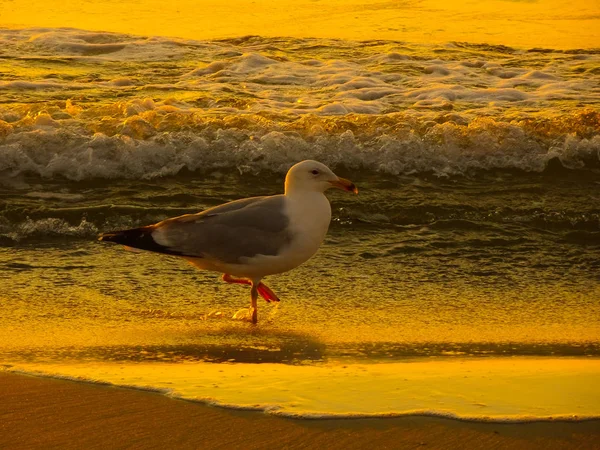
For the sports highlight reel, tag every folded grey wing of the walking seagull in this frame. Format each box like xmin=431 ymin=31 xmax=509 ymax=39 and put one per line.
xmin=152 ymin=195 xmax=291 ymax=264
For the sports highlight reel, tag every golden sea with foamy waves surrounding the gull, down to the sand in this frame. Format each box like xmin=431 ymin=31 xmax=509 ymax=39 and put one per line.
xmin=0 ymin=28 xmax=600 ymax=421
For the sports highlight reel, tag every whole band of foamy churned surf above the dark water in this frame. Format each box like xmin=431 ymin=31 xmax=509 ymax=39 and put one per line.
xmin=0 ymin=29 xmax=600 ymax=180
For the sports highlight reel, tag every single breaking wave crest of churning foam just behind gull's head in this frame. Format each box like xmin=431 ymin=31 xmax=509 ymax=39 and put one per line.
xmin=0 ymin=110 xmax=600 ymax=180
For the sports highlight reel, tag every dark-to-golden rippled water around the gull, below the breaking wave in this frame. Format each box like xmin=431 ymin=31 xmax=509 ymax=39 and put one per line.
xmin=0 ymin=170 xmax=600 ymax=362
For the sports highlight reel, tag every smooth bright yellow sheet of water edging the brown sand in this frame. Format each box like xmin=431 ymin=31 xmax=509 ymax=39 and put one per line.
xmin=5 ymin=358 xmax=600 ymax=423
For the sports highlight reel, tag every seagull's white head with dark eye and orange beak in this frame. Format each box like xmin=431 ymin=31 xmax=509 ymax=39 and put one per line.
xmin=285 ymin=160 xmax=358 ymax=194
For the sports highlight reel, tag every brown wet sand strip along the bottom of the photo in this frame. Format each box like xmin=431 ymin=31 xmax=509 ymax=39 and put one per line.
xmin=0 ymin=373 xmax=600 ymax=449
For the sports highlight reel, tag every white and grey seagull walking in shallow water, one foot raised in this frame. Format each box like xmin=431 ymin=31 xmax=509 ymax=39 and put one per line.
xmin=98 ymin=160 xmax=358 ymax=324
